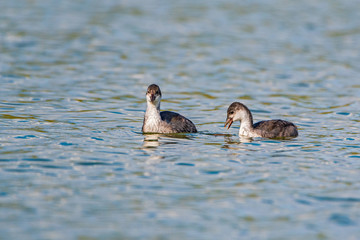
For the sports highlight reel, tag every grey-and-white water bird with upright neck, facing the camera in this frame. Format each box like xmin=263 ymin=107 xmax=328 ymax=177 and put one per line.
xmin=142 ymin=84 xmax=197 ymax=133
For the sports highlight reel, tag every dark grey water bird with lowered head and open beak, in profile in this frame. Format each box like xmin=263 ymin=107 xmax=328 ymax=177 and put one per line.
xmin=224 ymin=102 xmax=298 ymax=138
